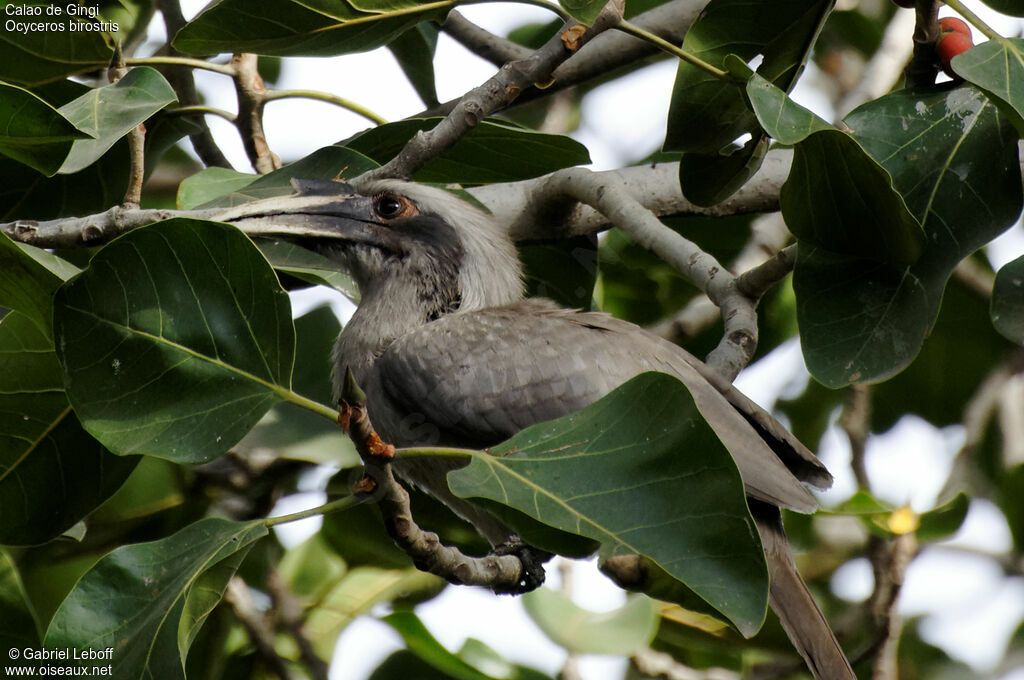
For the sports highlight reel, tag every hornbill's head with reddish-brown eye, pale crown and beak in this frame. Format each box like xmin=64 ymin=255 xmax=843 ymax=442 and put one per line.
xmin=260 ymin=179 xmax=522 ymax=317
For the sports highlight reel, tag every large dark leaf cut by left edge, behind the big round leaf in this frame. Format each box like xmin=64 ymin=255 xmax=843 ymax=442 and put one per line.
xmin=0 ymin=235 xmax=136 ymax=545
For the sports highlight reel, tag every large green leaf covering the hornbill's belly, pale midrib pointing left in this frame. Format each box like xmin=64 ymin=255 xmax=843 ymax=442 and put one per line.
xmin=449 ymin=374 xmax=768 ymax=634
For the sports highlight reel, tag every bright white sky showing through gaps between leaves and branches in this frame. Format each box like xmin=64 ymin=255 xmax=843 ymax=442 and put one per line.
xmin=153 ymin=0 xmax=1024 ymax=680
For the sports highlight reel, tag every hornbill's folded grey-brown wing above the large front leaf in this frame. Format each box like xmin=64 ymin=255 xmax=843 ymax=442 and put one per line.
xmin=367 ymin=300 xmax=827 ymax=512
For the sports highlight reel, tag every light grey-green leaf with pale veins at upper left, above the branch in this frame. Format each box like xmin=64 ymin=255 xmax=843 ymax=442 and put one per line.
xmin=60 ymin=67 xmax=177 ymax=174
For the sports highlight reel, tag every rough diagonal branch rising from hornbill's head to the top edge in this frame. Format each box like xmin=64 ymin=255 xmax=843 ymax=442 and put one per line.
xmin=364 ymin=0 xmax=623 ymax=182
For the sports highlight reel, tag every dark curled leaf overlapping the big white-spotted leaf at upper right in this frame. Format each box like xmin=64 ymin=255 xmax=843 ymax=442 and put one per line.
xmin=779 ymin=130 xmax=925 ymax=267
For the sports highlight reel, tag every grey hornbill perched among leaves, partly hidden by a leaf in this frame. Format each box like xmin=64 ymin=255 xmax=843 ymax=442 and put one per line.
xmin=270 ymin=180 xmax=855 ymax=680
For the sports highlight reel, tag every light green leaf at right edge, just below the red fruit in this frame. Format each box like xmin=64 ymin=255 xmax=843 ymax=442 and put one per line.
xmin=951 ymin=38 xmax=1024 ymax=135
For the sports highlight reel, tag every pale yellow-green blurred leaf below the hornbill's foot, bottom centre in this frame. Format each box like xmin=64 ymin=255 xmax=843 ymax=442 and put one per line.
xmin=522 ymin=588 xmax=658 ymax=656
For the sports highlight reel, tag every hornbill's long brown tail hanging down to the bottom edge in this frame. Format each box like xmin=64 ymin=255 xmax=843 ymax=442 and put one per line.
xmin=755 ymin=506 xmax=857 ymax=680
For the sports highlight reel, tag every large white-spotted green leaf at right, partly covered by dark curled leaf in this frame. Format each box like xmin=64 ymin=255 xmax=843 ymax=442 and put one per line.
xmin=794 ymin=85 xmax=1022 ymax=387
